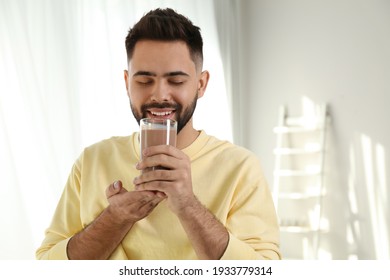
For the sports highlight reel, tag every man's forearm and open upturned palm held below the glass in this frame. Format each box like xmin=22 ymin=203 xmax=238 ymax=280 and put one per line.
xmin=67 ymin=181 xmax=165 ymax=260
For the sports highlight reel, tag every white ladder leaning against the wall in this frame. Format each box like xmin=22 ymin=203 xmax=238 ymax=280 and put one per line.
xmin=273 ymin=104 xmax=328 ymax=259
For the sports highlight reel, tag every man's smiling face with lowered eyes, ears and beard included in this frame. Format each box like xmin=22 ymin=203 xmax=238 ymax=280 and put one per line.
xmin=125 ymin=40 xmax=208 ymax=135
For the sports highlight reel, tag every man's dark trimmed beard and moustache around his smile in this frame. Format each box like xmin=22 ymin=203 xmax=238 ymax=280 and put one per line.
xmin=130 ymin=93 xmax=198 ymax=134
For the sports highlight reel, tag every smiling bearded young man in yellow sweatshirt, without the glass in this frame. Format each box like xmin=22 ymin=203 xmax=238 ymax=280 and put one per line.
xmin=36 ymin=9 xmax=280 ymax=259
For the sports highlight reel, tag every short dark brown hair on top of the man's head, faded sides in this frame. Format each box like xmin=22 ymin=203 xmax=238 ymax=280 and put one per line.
xmin=125 ymin=8 xmax=203 ymax=69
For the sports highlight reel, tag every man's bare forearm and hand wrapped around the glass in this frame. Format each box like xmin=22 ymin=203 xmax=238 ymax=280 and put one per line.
xmin=134 ymin=145 xmax=229 ymax=259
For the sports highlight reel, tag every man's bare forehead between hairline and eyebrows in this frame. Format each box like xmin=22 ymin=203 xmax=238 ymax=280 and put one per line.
xmin=129 ymin=40 xmax=195 ymax=72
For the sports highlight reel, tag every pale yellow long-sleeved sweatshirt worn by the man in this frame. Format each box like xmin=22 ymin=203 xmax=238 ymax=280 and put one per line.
xmin=36 ymin=131 xmax=280 ymax=260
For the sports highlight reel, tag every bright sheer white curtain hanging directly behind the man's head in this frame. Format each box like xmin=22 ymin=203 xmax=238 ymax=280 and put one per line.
xmin=0 ymin=0 xmax=232 ymax=259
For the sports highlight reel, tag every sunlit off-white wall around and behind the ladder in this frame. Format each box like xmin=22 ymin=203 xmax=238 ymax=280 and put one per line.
xmin=239 ymin=0 xmax=390 ymax=259
